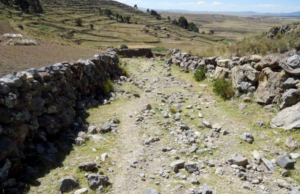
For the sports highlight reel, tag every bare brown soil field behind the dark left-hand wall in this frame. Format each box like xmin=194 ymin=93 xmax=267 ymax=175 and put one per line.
xmin=0 ymin=21 xmax=100 ymax=76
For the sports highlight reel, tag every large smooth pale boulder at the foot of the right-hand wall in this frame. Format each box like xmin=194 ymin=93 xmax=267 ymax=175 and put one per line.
xmin=270 ymin=103 xmax=300 ymax=130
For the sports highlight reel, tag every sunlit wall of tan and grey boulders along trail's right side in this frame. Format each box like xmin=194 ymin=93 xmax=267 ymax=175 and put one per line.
xmin=165 ymin=49 xmax=300 ymax=130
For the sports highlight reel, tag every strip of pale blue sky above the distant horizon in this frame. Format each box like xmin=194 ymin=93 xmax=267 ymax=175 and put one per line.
xmin=117 ymin=0 xmax=300 ymax=13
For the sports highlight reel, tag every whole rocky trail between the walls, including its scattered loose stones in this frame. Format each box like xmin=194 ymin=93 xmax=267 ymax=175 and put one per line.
xmin=29 ymin=56 xmax=300 ymax=194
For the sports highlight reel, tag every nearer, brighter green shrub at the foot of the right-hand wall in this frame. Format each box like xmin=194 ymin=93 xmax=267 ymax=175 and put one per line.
xmin=213 ymin=79 xmax=234 ymax=100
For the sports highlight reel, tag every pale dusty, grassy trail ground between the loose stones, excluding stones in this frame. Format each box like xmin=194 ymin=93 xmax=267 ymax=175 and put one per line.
xmin=30 ymin=59 xmax=300 ymax=194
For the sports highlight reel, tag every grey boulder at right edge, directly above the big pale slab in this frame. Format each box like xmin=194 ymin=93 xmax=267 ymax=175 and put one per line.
xmin=280 ymin=89 xmax=300 ymax=109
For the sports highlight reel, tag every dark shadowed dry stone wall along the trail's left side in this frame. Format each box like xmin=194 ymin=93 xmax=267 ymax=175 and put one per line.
xmin=0 ymin=51 xmax=122 ymax=189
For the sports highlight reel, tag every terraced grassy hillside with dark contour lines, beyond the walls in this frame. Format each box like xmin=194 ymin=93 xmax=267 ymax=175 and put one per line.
xmin=2 ymin=0 xmax=222 ymax=52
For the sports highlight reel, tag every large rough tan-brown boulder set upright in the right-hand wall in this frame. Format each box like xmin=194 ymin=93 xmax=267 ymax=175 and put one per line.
xmin=254 ymin=68 xmax=287 ymax=104
